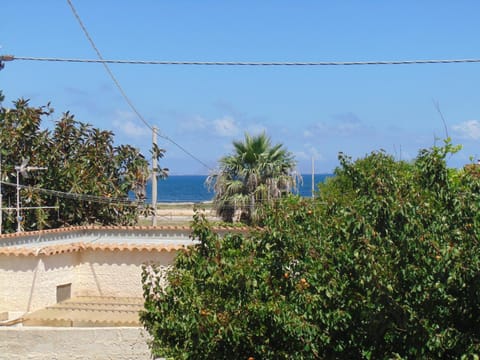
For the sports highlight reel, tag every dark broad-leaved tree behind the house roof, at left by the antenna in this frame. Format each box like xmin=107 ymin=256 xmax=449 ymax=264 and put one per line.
xmin=0 ymin=93 xmax=164 ymax=232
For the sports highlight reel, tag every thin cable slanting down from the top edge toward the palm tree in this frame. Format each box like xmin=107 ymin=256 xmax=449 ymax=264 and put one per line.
xmin=63 ymin=0 xmax=212 ymax=170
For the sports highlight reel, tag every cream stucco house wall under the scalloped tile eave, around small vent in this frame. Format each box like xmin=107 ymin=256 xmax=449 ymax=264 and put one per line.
xmin=0 ymin=250 xmax=176 ymax=312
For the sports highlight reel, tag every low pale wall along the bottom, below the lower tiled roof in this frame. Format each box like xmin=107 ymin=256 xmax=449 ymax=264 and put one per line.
xmin=0 ymin=327 xmax=158 ymax=360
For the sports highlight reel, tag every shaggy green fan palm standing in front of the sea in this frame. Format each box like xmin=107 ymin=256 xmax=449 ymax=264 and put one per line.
xmin=206 ymin=133 xmax=300 ymax=223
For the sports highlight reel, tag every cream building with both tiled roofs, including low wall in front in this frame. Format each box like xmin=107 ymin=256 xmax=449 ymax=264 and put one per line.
xmin=0 ymin=226 xmax=194 ymax=359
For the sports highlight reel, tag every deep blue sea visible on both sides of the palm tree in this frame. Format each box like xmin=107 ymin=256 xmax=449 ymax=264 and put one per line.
xmin=147 ymin=174 xmax=332 ymax=203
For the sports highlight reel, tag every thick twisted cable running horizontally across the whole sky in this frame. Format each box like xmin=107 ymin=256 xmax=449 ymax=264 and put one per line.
xmin=0 ymin=54 xmax=480 ymax=66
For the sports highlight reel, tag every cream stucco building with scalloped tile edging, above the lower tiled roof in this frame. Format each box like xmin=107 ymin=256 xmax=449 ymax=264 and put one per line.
xmin=0 ymin=226 xmax=193 ymax=320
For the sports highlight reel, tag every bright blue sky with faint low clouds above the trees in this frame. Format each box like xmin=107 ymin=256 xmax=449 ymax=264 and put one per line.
xmin=0 ymin=0 xmax=480 ymax=175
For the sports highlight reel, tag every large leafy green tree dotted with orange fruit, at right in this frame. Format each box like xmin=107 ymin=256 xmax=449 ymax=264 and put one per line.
xmin=141 ymin=141 xmax=480 ymax=359
